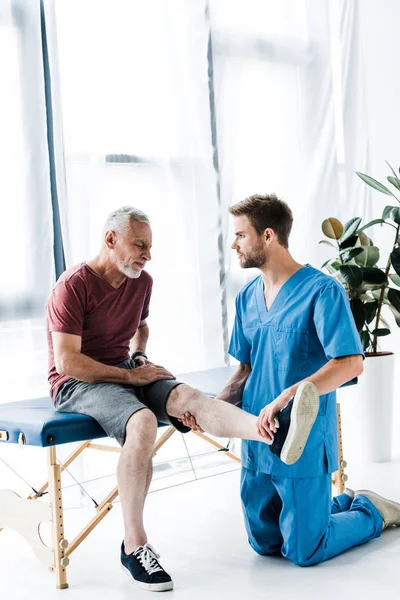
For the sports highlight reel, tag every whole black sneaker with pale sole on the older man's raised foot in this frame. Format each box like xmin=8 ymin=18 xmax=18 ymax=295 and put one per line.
xmin=270 ymin=381 xmax=319 ymax=465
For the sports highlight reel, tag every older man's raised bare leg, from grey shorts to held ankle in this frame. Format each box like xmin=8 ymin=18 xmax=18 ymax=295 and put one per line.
xmin=166 ymin=384 xmax=271 ymax=444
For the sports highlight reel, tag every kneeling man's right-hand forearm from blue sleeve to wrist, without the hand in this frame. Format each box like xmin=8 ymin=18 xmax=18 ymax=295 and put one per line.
xmin=289 ymin=355 xmax=363 ymax=396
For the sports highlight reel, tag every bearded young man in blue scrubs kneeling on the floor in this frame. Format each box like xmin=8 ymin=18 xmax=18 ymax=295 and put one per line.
xmin=184 ymin=194 xmax=400 ymax=566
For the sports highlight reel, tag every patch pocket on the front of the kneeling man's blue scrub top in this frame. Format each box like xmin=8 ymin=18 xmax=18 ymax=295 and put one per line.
xmin=271 ymin=327 xmax=308 ymax=372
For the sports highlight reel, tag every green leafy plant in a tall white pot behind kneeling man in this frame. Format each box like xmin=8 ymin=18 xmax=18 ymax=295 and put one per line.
xmin=320 ymin=164 xmax=400 ymax=461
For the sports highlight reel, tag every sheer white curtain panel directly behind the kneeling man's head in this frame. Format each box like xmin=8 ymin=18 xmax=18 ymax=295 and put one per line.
xmin=210 ymin=0 xmax=341 ymax=330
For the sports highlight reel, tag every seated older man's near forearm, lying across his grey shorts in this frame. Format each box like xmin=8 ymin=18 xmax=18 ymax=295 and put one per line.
xmin=56 ymin=352 xmax=129 ymax=384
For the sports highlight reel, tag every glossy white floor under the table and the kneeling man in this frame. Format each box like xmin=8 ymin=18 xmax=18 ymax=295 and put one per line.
xmin=0 ymin=454 xmax=400 ymax=600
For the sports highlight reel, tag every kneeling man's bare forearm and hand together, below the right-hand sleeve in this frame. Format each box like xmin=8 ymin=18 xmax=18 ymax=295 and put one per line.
xmin=257 ymin=354 xmax=363 ymax=437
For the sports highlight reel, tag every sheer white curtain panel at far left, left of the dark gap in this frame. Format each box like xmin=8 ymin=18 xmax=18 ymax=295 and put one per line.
xmin=0 ymin=0 xmax=54 ymax=403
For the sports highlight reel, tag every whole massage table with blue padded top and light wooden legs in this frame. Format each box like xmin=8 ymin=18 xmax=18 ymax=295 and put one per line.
xmin=0 ymin=366 xmax=347 ymax=589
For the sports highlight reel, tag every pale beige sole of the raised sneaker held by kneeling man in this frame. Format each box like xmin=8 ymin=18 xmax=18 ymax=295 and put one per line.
xmin=280 ymin=381 xmax=319 ymax=465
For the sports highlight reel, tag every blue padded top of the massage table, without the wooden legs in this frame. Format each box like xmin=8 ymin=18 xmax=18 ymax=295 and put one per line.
xmin=0 ymin=367 xmax=236 ymax=447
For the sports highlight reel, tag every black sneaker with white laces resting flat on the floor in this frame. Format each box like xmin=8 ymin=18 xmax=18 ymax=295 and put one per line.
xmin=121 ymin=542 xmax=174 ymax=592
